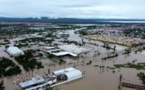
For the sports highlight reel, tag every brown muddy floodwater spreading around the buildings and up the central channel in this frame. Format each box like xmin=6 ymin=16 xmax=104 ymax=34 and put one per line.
xmin=0 ymin=30 xmax=145 ymax=90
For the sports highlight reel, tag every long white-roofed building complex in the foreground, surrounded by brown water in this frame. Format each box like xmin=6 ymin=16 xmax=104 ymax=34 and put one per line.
xmin=19 ymin=67 xmax=84 ymax=90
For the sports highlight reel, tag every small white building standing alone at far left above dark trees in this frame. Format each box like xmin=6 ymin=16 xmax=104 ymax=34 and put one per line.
xmin=7 ymin=47 xmax=24 ymax=56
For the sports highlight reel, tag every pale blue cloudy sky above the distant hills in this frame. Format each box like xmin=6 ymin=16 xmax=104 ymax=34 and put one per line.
xmin=0 ymin=0 xmax=145 ymax=19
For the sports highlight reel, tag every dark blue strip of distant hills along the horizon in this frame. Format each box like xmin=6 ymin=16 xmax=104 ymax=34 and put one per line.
xmin=0 ymin=17 xmax=145 ymax=23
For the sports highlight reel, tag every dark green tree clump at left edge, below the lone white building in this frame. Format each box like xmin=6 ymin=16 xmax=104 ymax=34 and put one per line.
xmin=0 ymin=57 xmax=21 ymax=77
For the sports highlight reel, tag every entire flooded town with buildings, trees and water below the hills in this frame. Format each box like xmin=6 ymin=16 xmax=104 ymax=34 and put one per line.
xmin=0 ymin=21 xmax=145 ymax=90
